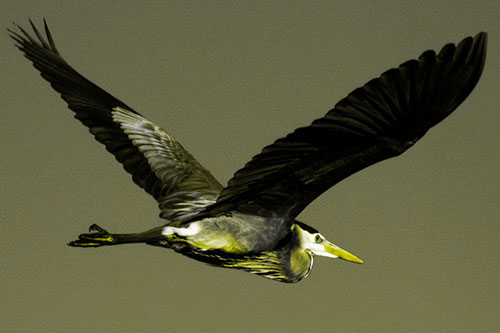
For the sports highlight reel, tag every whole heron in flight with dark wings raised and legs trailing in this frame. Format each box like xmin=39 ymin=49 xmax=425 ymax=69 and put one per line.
xmin=8 ymin=20 xmax=487 ymax=282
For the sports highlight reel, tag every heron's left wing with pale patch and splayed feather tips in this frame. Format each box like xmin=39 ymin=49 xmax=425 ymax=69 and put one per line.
xmin=9 ymin=20 xmax=222 ymax=223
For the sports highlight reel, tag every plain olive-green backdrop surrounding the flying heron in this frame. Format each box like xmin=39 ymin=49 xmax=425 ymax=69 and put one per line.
xmin=0 ymin=0 xmax=500 ymax=332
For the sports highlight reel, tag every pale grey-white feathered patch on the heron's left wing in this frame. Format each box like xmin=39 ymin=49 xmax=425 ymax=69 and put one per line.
xmin=111 ymin=107 xmax=222 ymax=221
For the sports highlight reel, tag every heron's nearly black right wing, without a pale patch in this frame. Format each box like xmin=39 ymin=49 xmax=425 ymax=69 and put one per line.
xmin=204 ymin=32 xmax=487 ymax=220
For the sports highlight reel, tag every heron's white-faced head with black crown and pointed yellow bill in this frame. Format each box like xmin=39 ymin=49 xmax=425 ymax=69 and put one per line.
xmin=292 ymin=221 xmax=363 ymax=264
